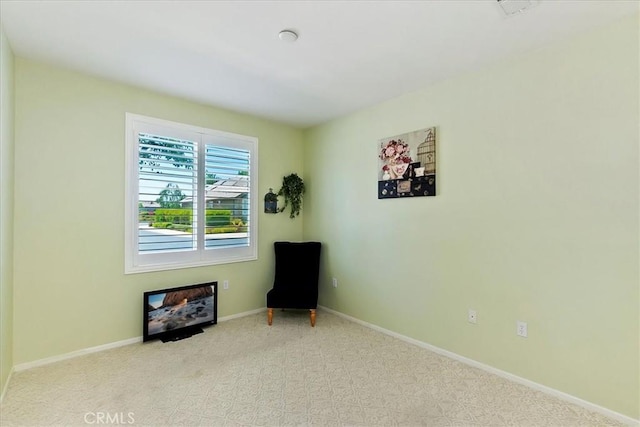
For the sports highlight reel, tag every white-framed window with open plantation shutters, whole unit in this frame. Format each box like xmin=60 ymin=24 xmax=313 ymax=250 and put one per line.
xmin=125 ymin=113 xmax=258 ymax=273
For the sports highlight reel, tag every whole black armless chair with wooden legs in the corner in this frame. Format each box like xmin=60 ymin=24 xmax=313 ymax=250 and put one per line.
xmin=267 ymin=242 xmax=321 ymax=326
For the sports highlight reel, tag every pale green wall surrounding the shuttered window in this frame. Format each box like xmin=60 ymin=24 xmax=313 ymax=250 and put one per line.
xmin=13 ymin=57 xmax=303 ymax=365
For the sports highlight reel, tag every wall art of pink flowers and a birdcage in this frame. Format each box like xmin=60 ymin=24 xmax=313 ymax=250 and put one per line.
xmin=378 ymin=127 xmax=436 ymax=199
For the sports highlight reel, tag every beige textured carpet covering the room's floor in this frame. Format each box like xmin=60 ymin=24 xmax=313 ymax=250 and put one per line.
xmin=0 ymin=311 xmax=621 ymax=427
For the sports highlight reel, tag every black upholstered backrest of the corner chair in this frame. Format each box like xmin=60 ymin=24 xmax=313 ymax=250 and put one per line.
xmin=273 ymin=242 xmax=321 ymax=293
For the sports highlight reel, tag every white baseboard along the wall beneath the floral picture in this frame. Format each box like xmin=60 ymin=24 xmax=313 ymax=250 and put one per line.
xmin=318 ymin=306 xmax=640 ymax=427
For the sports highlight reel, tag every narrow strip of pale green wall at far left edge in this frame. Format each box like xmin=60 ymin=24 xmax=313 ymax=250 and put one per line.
xmin=0 ymin=27 xmax=14 ymax=393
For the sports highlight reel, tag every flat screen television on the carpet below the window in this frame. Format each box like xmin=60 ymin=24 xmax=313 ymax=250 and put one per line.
xmin=142 ymin=282 xmax=218 ymax=342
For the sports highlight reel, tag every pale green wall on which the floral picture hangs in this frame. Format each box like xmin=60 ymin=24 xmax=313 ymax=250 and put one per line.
xmin=304 ymin=12 xmax=640 ymax=419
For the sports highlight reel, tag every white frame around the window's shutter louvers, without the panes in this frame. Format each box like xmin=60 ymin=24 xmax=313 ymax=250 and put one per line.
xmin=124 ymin=113 xmax=258 ymax=274
